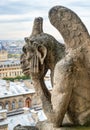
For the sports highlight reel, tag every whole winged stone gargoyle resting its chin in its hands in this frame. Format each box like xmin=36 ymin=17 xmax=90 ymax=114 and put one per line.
xmin=21 ymin=6 xmax=90 ymax=127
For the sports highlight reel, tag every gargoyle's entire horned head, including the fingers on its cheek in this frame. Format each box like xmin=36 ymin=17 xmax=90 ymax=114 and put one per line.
xmin=21 ymin=17 xmax=65 ymax=75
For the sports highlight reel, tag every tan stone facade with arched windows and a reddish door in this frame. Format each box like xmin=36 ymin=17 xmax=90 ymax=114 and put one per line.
xmin=0 ymin=94 xmax=33 ymax=111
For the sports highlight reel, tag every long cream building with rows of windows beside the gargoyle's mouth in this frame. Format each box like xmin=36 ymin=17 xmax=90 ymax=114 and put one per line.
xmin=0 ymin=60 xmax=23 ymax=79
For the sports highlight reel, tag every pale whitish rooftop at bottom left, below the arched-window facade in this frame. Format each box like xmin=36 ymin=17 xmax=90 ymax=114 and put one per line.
xmin=0 ymin=110 xmax=47 ymax=130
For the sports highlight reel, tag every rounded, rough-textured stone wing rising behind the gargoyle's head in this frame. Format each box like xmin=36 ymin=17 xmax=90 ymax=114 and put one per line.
xmin=49 ymin=6 xmax=90 ymax=49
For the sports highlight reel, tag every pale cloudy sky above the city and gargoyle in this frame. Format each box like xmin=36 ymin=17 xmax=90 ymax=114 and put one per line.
xmin=0 ymin=0 xmax=90 ymax=40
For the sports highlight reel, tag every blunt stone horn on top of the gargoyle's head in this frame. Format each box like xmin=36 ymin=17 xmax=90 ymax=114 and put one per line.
xmin=30 ymin=17 xmax=43 ymax=37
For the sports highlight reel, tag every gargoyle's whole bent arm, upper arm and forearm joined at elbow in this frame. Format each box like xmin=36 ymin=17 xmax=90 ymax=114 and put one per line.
xmin=34 ymin=58 xmax=73 ymax=127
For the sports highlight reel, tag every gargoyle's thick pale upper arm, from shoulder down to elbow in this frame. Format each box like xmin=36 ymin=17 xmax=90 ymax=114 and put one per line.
xmin=49 ymin=59 xmax=74 ymax=127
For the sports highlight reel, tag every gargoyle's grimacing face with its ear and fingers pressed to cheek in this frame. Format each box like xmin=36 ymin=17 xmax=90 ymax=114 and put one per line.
xmin=21 ymin=38 xmax=47 ymax=75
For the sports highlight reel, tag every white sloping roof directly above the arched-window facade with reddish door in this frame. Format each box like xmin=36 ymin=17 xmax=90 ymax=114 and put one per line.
xmin=0 ymin=79 xmax=35 ymax=98
